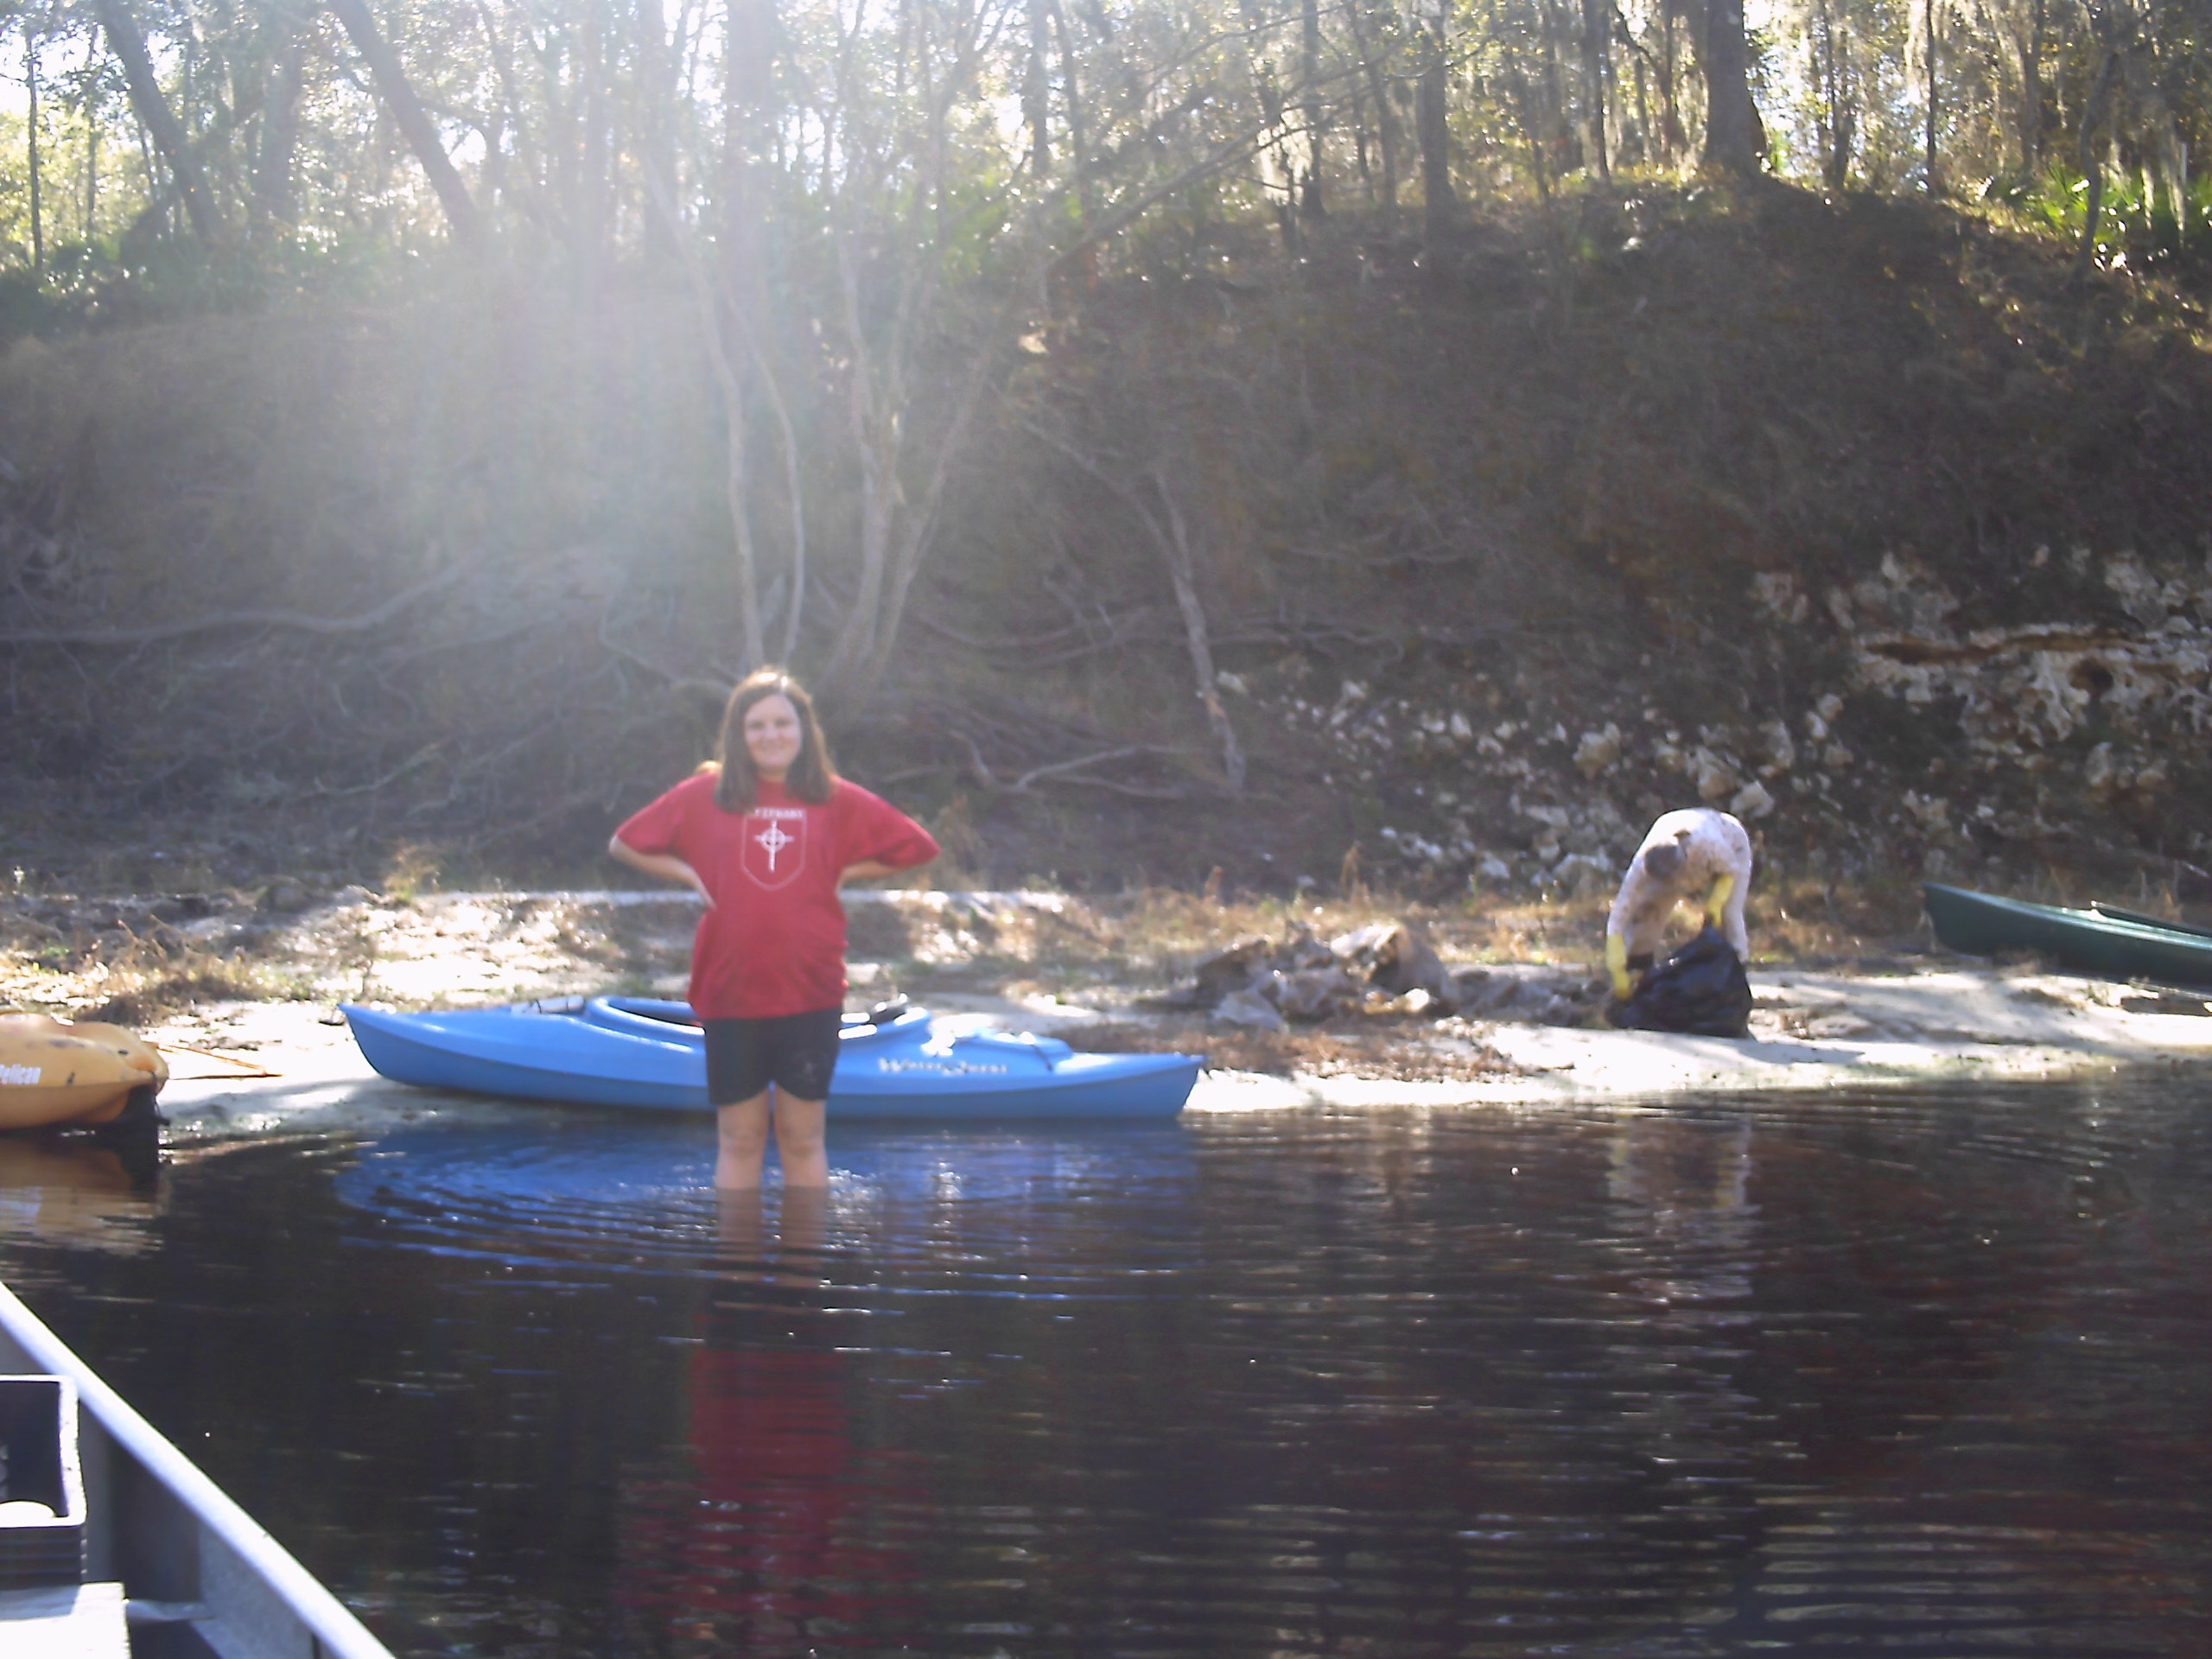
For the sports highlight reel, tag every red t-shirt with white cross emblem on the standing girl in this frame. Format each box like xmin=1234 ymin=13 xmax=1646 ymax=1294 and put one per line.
xmin=615 ymin=772 xmax=938 ymax=1020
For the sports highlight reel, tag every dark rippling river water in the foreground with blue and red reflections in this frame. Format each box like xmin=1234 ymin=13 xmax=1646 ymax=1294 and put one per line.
xmin=0 ymin=1082 xmax=2212 ymax=1659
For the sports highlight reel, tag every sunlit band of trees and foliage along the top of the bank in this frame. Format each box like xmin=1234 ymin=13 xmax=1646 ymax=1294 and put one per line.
xmin=0 ymin=0 xmax=2212 ymax=288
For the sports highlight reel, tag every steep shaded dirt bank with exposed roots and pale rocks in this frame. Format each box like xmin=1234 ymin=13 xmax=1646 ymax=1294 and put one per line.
xmin=0 ymin=186 xmax=2212 ymax=925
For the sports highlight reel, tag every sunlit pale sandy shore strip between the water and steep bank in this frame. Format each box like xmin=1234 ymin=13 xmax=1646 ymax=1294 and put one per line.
xmin=13 ymin=889 xmax=2212 ymax=1141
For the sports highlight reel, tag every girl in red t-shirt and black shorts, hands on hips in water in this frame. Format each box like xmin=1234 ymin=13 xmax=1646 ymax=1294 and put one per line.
xmin=606 ymin=668 xmax=938 ymax=1192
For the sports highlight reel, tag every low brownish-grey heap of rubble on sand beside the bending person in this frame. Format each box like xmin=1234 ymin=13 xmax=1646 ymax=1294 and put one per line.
xmin=1141 ymin=923 xmax=1604 ymax=1031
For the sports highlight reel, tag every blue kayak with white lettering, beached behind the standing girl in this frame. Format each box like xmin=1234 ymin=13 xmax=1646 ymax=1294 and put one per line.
xmin=343 ymin=998 xmax=1204 ymax=1119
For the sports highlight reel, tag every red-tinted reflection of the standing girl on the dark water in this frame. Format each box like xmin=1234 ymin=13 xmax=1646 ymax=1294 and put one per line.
xmin=621 ymin=1188 xmax=913 ymax=1655
